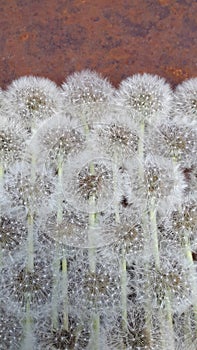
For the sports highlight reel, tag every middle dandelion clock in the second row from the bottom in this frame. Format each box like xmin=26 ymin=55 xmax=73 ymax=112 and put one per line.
xmin=68 ymin=256 xmax=120 ymax=317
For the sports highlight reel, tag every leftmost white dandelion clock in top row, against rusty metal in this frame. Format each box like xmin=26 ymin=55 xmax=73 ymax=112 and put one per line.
xmin=5 ymin=76 xmax=62 ymax=131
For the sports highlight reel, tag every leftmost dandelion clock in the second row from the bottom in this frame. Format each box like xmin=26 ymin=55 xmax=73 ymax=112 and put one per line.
xmin=1 ymin=251 xmax=52 ymax=310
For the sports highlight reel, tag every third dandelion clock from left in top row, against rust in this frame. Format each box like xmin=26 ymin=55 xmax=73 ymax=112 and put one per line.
xmin=116 ymin=73 xmax=172 ymax=124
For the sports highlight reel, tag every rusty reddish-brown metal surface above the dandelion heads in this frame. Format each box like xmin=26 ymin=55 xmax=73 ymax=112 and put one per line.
xmin=0 ymin=0 xmax=197 ymax=88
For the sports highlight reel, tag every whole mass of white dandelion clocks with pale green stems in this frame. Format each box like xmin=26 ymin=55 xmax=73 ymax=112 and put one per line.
xmin=0 ymin=70 xmax=197 ymax=350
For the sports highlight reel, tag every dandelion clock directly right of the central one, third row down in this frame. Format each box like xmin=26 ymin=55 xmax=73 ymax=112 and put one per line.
xmin=124 ymin=155 xmax=186 ymax=213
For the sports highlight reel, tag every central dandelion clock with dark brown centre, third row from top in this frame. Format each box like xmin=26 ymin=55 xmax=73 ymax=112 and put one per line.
xmin=62 ymin=151 xmax=121 ymax=213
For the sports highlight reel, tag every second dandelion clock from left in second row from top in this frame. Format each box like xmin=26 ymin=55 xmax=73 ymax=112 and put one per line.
xmin=26 ymin=114 xmax=85 ymax=176
